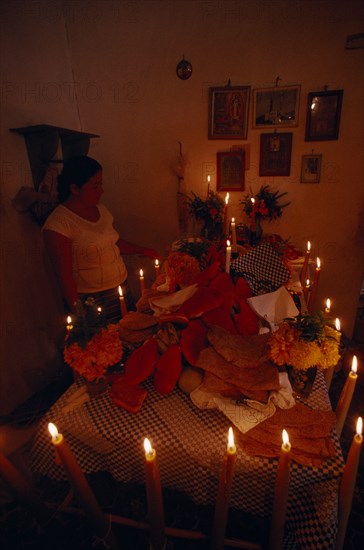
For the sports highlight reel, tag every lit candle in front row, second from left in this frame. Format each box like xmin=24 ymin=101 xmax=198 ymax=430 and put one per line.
xmin=144 ymin=438 xmax=166 ymax=550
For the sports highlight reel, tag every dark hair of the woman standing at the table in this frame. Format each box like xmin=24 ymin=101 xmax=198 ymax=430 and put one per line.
xmin=57 ymin=155 xmax=102 ymax=202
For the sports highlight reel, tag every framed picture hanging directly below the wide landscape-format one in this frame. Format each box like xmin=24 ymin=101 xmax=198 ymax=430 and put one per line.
xmin=259 ymin=132 xmax=292 ymax=176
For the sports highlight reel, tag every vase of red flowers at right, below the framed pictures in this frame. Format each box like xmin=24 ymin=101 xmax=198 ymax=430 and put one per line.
xmin=240 ymin=185 xmax=290 ymax=246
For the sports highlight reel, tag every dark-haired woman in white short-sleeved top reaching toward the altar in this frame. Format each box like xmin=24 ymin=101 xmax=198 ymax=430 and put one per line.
xmin=43 ymin=156 xmax=157 ymax=321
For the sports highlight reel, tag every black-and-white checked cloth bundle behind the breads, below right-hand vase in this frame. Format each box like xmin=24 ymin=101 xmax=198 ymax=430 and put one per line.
xmin=230 ymin=243 xmax=291 ymax=295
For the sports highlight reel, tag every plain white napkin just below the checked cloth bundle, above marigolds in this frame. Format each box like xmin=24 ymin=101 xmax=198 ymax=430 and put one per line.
xmin=247 ymin=286 xmax=299 ymax=332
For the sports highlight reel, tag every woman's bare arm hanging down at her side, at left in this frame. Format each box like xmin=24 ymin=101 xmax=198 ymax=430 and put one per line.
xmin=43 ymin=229 xmax=79 ymax=311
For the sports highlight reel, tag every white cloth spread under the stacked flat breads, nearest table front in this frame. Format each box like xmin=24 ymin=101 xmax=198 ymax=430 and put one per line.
xmin=190 ymin=372 xmax=295 ymax=433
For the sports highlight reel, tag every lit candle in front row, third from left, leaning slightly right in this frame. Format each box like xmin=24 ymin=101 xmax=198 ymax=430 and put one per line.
xmin=210 ymin=427 xmax=236 ymax=550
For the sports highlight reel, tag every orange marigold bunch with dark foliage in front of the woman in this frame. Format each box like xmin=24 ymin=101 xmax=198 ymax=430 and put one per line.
xmin=63 ymin=298 xmax=123 ymax=382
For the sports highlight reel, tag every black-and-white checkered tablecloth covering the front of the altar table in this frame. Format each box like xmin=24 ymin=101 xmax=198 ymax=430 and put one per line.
xmin=32 ymin=373 xmax=343 ymax=549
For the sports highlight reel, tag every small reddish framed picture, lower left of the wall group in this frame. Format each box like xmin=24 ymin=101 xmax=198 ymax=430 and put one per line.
xmin=216 ymin=149 xmax=245 ymax=191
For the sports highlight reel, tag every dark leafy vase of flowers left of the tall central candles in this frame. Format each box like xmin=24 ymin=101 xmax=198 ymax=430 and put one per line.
xmin=185 ymin=190 xmax=225 ymax=241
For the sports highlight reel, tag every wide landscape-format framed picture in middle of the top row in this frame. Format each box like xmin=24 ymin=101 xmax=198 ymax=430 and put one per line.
xmin=253 ymin=85 xmax=301 ymax=128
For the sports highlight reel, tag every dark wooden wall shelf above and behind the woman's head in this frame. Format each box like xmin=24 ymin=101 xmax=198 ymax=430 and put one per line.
xmin=10 ymin=124 xmax=100 ymax=191
